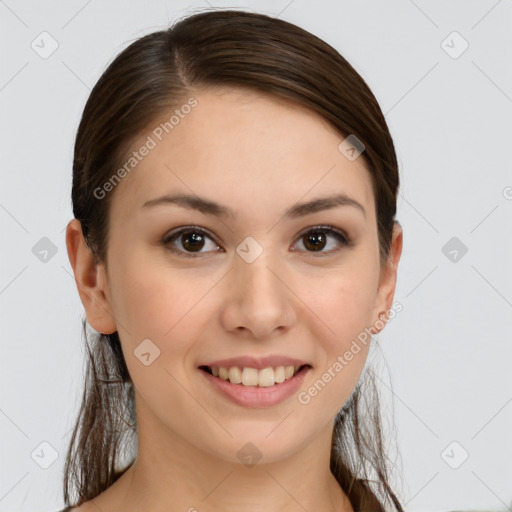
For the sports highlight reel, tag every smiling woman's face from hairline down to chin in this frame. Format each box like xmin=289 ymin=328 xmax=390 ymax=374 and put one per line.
xmin=80 ymin=88 xmax=402 ymax=462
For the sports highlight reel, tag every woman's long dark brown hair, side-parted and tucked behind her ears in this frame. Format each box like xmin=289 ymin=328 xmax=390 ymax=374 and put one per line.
xmin=64 ymin=10 xmax=402 ymax=511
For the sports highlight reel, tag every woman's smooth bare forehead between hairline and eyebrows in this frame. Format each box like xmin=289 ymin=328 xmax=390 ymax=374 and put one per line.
xmin=112 ymin=87 xmax=373 ymax=222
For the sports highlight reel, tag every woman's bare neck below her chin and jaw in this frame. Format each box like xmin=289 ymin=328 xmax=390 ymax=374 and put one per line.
xmin=99 ymin=400 xmax=353 ymax=512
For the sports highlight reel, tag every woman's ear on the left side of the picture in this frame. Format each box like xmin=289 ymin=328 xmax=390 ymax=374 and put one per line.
xmin=66 ymin=219 xmax=117 ymax=334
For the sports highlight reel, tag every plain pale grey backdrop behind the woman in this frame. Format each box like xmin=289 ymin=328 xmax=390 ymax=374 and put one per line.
xmin=0 ymin=0 xmax=512 ymax=512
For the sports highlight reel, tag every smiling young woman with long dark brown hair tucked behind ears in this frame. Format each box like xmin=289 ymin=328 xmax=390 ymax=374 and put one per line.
xmin=64 ymin=10 xmax=402 ymax=512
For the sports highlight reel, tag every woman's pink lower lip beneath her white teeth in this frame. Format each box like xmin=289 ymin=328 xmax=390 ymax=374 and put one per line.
xmin=199 ymin=366 xmax=311 ymax=408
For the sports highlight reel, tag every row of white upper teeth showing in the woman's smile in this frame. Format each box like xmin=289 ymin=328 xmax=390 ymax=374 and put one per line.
xmin=210 ymin=366 xmax=300 ymax=387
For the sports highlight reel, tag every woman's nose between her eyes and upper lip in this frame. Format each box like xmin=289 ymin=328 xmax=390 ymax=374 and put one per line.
xmin=222 ymin=251 xmax=296 ymax=339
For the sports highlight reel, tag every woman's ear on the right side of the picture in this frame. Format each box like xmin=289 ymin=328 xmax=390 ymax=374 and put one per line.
xmin=370 ymin=221 xmax=403 ymax=334
